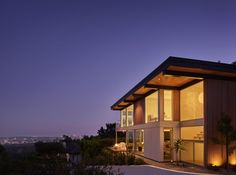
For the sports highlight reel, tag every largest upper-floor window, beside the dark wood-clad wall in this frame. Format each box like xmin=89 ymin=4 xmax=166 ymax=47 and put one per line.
xmin=180 ymin=82 xmax=203 ymax=121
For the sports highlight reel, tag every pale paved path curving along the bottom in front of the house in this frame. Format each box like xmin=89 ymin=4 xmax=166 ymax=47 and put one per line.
xmin=112 ymin=165 xmax=219 ymax=175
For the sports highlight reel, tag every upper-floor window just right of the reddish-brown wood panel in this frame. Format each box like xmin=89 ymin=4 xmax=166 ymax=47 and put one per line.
xmin=145 ymin=92 xmax=158 ymax=123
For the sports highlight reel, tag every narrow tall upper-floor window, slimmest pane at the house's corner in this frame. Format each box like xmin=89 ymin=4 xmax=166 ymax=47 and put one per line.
xmin=164 ymin=90 xmax=173 ymax=121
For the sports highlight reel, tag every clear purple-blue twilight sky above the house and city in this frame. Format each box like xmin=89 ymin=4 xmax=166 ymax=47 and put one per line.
xmin=0 ymin=0 xmax=236 ymax=136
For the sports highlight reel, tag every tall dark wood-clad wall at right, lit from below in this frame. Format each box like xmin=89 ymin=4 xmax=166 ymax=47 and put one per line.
xmin=204 ymin=79 xmax=236 ymax=165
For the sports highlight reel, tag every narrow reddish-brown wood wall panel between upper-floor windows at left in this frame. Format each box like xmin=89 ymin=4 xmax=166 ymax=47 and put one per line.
xmin=134 ymin=98 xmax=145 ymax=125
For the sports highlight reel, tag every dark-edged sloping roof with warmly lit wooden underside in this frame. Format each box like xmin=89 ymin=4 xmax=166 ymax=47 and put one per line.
xmin=111 ymin=56 xmax=236 ymax=110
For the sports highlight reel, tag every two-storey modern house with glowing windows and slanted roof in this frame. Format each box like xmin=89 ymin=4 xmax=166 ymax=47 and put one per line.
xmin=111 ymin=57 xmax=236 ymax=166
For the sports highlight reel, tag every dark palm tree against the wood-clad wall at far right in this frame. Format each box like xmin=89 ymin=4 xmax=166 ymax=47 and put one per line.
xmin=217 ymin=113 xmax=236 ymax=169
